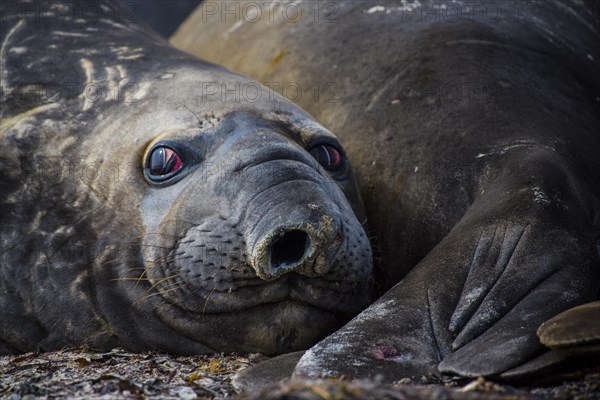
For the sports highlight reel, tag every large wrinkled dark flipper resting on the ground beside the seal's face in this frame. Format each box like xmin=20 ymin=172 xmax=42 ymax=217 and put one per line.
xmin=295 ymin=148 xmax=600 ymax=381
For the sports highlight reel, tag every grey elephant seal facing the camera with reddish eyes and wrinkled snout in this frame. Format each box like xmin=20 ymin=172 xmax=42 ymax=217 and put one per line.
xmin=0 ymin=1 xmax=372 ymax=354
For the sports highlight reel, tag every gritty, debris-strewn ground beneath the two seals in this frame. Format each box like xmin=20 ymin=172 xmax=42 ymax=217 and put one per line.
xmin=0 ymin=349 xmax=600 ymax=400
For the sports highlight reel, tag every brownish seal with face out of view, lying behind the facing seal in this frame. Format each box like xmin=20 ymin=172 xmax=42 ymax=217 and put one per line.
xmin=171 ymin=0 xmax=600 ymax=381
